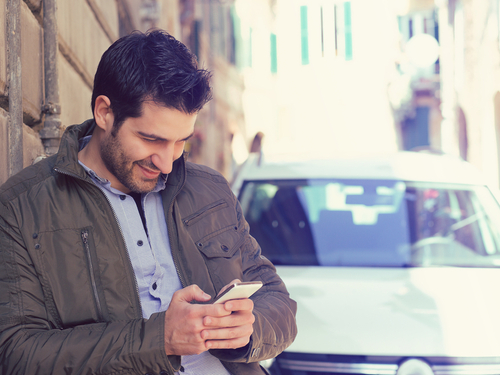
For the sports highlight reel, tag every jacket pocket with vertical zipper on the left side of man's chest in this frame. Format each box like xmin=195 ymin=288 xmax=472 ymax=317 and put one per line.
xmin=35 ymin=227 xmax=108 ymax=328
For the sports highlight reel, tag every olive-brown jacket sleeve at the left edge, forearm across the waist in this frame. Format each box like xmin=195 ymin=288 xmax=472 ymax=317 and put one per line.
xmin=0 ymin=203 xmax=178 ymax=375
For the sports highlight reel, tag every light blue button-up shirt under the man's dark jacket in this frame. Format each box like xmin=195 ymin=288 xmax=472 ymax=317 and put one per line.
xmin=80 ymin=136 xmax=230 ymax=375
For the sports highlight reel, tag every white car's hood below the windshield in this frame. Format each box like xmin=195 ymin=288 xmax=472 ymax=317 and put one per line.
xmin=278 ymin=266 xmax=500 ymax=357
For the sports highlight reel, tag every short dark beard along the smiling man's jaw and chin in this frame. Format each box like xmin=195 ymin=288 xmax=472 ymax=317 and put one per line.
xmin=100 ymin=134 xmax=158 ymax=193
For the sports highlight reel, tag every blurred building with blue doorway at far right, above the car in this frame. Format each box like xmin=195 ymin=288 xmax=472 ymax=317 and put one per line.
xmin=394 ymin=0 xmax=500 ymax=187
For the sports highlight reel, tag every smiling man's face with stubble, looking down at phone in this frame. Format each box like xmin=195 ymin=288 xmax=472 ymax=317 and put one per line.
xmin=100 ymin=102 xmax=197 ymax=193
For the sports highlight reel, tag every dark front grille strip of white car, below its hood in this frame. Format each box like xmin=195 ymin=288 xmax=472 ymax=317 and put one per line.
xmin=271 ymin=352 xmax=500 ymax=375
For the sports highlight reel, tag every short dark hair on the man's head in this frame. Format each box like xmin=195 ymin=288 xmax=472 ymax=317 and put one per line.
xmin=92 ymin=30 xmax=212 ymax=134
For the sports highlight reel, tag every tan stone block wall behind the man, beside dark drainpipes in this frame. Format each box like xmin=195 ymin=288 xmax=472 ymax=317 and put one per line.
xmin=0 ymin=0 xmax=140 ymax=184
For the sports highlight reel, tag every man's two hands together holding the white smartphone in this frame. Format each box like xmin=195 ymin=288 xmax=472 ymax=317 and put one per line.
xmin=165 ymin=285 xmax=255 ymax=355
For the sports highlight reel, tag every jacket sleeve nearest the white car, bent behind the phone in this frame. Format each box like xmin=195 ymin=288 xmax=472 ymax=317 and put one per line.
xmin=211 ymin=198 xmax=297 ymax=363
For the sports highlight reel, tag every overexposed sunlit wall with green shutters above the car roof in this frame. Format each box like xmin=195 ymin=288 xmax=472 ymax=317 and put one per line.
xmin=237 ymin=0 xmax=399 ymax=160
